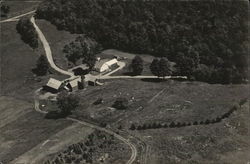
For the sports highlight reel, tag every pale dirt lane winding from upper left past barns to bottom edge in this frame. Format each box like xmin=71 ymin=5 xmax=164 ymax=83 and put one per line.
xmin=30 ymin=17 xmax=137 ymax=164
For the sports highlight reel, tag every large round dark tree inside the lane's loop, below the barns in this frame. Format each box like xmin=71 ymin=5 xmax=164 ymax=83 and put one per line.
xmin=57 ymin=91 xmax=79 ymax=116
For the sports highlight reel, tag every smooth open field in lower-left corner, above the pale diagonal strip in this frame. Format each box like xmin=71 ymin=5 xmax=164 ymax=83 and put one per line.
xmin=0 ymin=97 xmax=71 ymax=163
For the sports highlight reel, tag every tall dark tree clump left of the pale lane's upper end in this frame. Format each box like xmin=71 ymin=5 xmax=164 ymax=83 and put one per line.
xmin=16 ymin=18 xmax=38 ymax=49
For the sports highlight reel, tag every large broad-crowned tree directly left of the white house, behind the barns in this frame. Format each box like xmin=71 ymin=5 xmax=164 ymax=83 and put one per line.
xmin=63 ymin=36 xmax=101 ymax=69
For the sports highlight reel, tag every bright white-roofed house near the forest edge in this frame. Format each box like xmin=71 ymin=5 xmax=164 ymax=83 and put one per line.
xmin=95 ymin=59 xmax=118 ymax=72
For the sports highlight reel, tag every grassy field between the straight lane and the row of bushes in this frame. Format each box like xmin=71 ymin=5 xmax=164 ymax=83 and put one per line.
xmin=69 ymin=79 xmax=249 ymax=126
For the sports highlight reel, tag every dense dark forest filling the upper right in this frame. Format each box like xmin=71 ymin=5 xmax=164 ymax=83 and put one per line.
xmin=36 ymin=0 xmax=248 ymax=83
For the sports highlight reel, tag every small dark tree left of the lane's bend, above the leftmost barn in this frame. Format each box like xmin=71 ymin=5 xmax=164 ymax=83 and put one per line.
xmin=35 ymin=55 xmax=49 ymax=76
